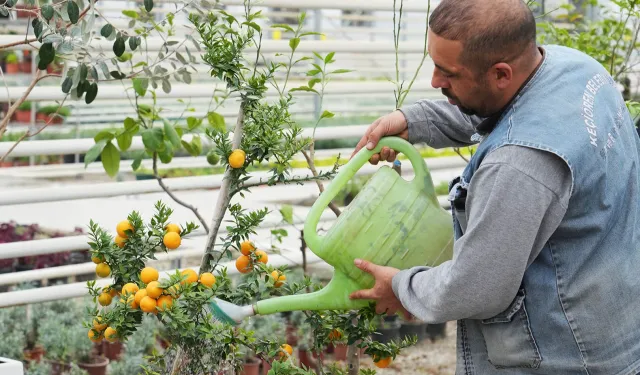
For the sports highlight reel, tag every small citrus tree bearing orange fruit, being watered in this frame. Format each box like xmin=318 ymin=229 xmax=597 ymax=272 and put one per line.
xmin=80 ymin=1 xmax=416 ymax=374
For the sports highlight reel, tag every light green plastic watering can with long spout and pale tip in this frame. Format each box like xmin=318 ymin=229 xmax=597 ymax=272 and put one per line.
xmin=212 ymin=137 xmax=453 ymax=323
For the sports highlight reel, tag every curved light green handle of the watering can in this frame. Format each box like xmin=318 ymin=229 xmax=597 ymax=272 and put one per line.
xmin=304 ymin=137 xmax=439 ymax=254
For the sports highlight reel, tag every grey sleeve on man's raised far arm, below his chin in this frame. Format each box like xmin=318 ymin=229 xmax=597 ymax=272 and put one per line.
xmin=400 ymin=99 xmax=483 ymax=148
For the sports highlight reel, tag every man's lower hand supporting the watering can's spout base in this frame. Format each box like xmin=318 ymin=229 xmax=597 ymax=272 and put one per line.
xmin=349 ymin=259 xmax=410 ymax=318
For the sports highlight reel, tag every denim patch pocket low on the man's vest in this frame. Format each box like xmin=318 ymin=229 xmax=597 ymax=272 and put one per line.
xmin=480 ymin=289 xmax=542 ymax=368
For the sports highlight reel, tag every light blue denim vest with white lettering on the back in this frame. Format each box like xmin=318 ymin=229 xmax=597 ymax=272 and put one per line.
xmin=451 ymin=46 xmax=640 ymax=375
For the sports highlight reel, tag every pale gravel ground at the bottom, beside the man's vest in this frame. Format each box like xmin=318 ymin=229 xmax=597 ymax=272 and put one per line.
xmin=330 ymin=322 xmax=456 ymax=375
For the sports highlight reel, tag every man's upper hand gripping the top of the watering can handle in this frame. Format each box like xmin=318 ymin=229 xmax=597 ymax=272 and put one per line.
xmin=351 ymin=110 xmax=409 ymax=165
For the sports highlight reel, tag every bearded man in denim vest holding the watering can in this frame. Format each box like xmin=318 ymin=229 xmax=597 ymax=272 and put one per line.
xmin=351 ymin=0 xmax=640 ymax=375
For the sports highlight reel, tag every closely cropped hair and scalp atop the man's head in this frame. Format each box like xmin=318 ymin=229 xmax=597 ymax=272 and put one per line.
xmin=429 ymin=0 xmax=537 ymax=73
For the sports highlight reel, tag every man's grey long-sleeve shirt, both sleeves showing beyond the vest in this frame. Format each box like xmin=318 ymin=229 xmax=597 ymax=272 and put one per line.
xmin=393 ymin=100 xmax=571 ymax=324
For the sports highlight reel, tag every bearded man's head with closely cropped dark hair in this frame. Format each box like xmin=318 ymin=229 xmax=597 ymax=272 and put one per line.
xmin=428 ymin=0 xmax=540 ymax=117
